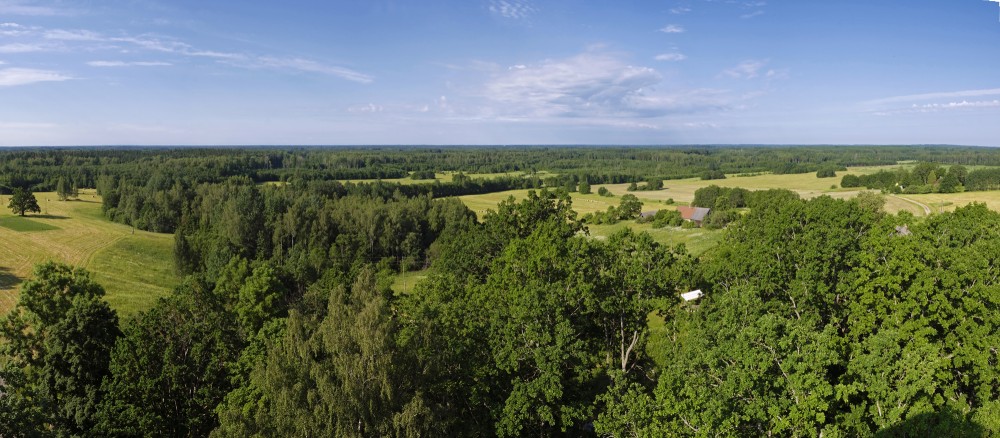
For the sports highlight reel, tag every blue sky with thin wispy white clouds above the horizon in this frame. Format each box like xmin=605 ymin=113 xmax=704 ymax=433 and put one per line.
xmin=0 ymin=0 xmax=1000 ymax=146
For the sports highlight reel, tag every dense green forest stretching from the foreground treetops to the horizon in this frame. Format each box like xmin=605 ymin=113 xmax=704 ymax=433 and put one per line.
xmin=0 ymin=146 xmax=1000 ymax=437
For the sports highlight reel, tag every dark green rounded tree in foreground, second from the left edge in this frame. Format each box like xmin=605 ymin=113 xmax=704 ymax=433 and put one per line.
xmin=98 ymin=283 xmax=239 ymax=436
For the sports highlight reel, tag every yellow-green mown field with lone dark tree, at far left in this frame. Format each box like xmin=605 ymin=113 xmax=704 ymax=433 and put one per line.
xmin=0 ymin=190 xmax=180 ymax=315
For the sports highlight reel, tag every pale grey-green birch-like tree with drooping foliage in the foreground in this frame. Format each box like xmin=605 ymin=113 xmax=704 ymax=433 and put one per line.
xmin=216 ymin=268 xmax=434 ymax=436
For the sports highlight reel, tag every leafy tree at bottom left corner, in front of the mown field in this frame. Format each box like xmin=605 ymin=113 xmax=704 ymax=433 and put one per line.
xmin=0 ymin=262 xmax=119 ymax=436
